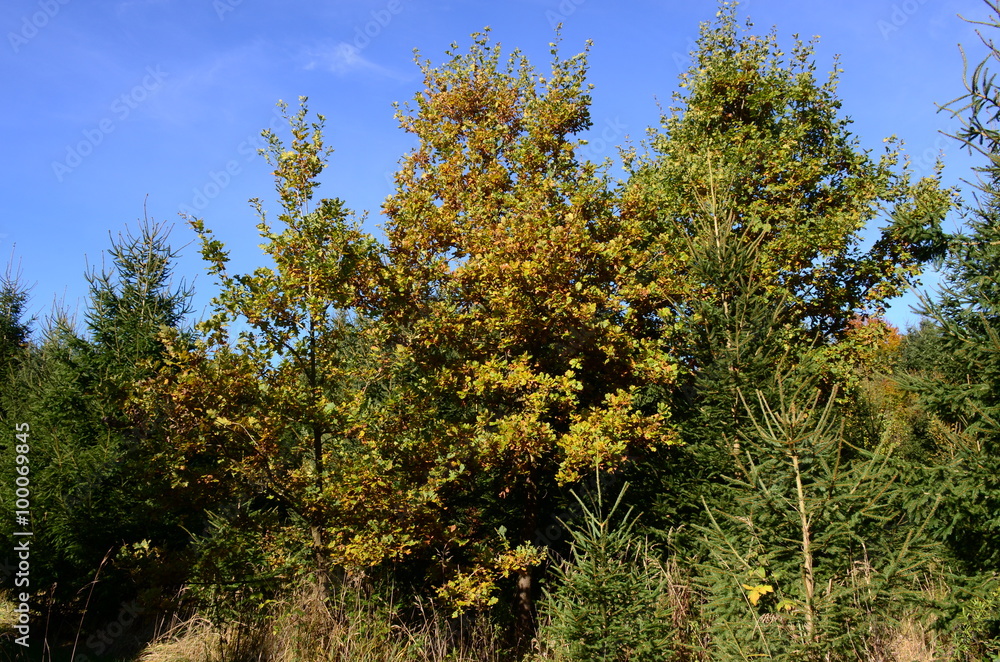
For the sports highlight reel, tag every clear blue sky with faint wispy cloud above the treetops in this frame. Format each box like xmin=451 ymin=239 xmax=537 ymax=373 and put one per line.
xmin=0 ymin=0 xmax=988 ymax=334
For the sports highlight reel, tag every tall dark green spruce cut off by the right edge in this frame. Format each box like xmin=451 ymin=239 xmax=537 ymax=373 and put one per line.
xmin=906 ymin=1 xmax=1000 ymax=592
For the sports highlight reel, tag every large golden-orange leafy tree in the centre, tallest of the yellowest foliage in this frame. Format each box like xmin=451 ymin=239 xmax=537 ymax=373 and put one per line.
xmin=373 ymin=33 xmax=674 ymax=644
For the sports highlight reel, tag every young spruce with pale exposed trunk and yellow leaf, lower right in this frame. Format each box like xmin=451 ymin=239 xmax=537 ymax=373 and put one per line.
xmin=698 ymin=376 xmax=939 ymax=661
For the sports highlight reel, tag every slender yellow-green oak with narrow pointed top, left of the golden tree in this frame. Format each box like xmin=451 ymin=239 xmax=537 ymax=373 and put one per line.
xmin=144 ymin=99 xmax=377 ymax=578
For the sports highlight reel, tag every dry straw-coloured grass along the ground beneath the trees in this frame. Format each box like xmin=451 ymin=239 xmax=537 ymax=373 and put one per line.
xmin=129 ymin=563 xmax=956 ymax=662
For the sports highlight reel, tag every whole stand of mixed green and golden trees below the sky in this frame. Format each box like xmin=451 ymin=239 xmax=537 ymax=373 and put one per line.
xmin=0 ymin=2 xmax=1000 ymax=662
